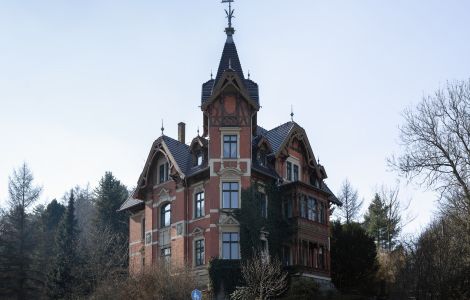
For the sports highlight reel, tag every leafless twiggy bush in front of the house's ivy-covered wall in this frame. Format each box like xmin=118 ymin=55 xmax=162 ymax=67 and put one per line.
xmin=231 ymin=252 xmax=287 ymax=300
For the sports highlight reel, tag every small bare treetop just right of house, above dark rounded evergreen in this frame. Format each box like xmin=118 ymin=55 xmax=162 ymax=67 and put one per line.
xmin=338 ymin=179 xmax=363 ymax=224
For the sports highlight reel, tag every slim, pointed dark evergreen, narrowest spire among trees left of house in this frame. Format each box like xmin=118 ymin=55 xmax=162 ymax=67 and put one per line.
xmin=49 ymin=190 xmax=79 ymax=299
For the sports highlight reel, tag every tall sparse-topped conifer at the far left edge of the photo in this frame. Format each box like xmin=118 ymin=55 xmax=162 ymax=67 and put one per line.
xmin=0 ymin=163 xmax=41 ymax=299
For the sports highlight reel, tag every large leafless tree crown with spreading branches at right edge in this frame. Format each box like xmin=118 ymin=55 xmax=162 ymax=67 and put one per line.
xmin=389 ymin=80 xmax=470 ymax=216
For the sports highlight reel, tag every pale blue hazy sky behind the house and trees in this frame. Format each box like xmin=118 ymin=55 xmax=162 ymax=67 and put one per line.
xmin=0 ymin=0 xmax=470 ymax=238
